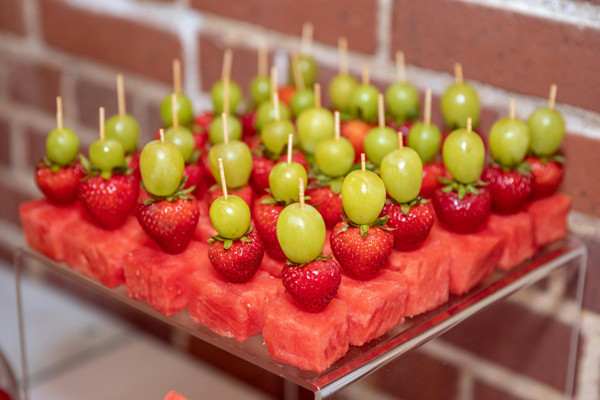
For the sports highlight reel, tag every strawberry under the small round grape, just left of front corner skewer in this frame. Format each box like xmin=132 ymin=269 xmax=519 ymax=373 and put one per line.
xmin=208 ymin=230 xmax=265 ymax=283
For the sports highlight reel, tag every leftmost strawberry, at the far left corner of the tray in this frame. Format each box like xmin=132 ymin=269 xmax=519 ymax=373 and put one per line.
xmin=35 ymin=161 xmax=85 ymax=204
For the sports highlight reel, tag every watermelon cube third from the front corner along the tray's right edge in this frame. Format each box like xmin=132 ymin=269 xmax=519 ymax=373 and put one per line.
xmin=388 ymin=236 xmax=450 ymax=317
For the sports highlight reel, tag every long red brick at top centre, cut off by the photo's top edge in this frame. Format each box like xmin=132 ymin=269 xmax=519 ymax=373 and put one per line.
xmin=191 ymin=0 xmax=377 ymax=54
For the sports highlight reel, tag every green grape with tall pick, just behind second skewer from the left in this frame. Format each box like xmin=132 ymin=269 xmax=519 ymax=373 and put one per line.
xmin=105 ymin=74 xmax=140 ymax=154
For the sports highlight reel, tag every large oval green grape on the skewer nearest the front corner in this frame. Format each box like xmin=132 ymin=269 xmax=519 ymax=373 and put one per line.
xmin=277 ymin=203 xmax=325 ymax=264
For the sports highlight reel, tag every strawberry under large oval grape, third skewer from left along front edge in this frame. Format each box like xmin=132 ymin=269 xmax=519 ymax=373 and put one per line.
xmin=136 ymin=192 xmax=200 ymax=254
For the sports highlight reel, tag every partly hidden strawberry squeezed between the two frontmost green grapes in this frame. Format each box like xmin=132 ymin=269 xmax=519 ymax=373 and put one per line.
xmin=252 ymin=194 xmax=287 ymax=261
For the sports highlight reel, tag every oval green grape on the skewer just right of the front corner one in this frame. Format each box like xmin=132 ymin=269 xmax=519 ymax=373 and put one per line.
xmin=342 ymin=170 xmax=386 ymax=225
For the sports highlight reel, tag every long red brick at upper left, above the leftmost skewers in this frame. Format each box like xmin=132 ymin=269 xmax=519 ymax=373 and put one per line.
xmin=39 ymin=0 xmax=181 ymax=83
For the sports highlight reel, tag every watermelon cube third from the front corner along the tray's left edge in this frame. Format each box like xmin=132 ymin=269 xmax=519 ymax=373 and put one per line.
xmin=123 ymin=242 xmax=213 ymax=316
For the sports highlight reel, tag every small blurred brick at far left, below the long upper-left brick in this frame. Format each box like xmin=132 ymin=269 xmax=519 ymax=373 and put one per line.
xmin=5 ymin=57 xmax=61 ymax=114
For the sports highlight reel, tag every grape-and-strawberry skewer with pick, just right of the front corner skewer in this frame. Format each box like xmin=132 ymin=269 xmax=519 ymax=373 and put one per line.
xmin=331 ymin=154 xmax=394 ymax=280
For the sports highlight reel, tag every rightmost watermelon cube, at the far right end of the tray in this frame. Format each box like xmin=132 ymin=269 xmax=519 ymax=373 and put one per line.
xmin=526 ymin=193 xmax=571 ymax=247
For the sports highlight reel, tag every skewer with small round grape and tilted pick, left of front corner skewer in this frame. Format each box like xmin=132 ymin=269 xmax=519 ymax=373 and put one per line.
xmin=208 ymin=159 xmax=264 ymax=283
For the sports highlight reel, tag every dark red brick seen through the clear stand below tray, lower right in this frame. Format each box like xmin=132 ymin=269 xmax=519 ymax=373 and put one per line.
xmin=442 ymin=302 xmax=571 ymax=390
